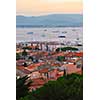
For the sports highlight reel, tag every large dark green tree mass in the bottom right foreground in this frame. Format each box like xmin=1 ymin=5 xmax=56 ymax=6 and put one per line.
xmin=17 ymin=74 xmax=83 ymax=100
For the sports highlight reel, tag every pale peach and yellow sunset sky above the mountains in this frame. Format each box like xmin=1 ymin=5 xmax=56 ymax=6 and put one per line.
xmin=16 ymin=0 xmax=83 ymax=16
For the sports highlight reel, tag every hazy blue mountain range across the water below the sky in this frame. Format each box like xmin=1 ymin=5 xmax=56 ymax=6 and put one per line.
xmin=16 ymin=14 xmax=83 ymax=27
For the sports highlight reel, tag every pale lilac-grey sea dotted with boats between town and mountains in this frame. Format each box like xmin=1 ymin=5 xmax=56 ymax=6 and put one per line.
xmin=16 ymin=27 xmax=83 ymax=44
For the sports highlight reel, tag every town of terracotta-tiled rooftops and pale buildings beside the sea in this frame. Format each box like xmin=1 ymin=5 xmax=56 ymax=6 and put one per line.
xmin=16 ymin=43 xmax=83 ymax=91
